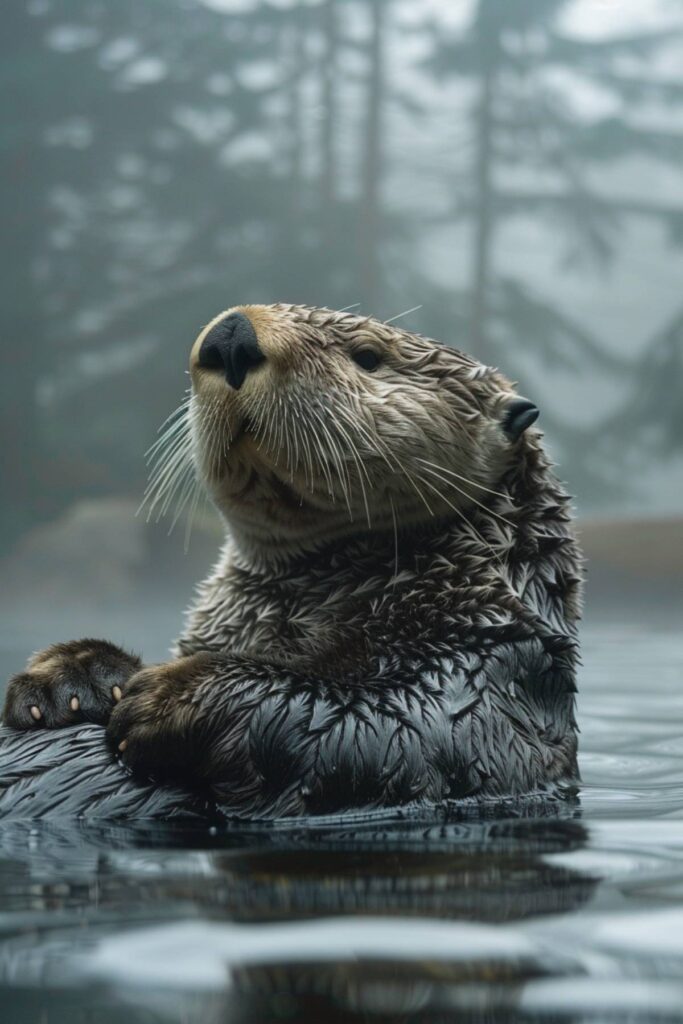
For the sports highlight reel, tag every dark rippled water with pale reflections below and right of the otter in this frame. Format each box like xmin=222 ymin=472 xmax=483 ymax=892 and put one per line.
xmin=0 ymin=631 xmax=683 ymax=1024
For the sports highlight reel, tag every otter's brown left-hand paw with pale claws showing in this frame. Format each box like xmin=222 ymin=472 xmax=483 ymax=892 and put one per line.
xmin=3 ymin=640 xmax=142 ymax=729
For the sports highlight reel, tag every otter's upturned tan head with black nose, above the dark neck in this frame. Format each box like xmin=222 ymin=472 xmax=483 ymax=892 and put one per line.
xmin=189 ymin=305 xmax=538 ymax=547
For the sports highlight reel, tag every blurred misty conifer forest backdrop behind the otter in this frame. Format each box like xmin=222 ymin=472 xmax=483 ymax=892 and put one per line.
xmin=0 ymin=0 xmax=683 ymax=671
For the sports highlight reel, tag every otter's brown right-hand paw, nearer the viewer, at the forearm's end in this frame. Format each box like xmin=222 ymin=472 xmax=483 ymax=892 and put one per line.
xmin=106 ymin=657 xmax=199 ymax=779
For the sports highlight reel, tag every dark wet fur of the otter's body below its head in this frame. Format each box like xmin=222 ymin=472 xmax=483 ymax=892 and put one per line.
xmin=0 ymin=315 xmax=583 ymax=819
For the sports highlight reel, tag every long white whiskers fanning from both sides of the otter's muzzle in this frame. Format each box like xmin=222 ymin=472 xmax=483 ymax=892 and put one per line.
xmin=138 ymin=374 xmax=514 ymax=575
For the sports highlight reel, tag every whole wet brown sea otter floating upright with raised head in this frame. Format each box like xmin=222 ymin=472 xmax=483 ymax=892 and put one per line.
xmin=0 ymin=304 xmax=582 ymax=818
